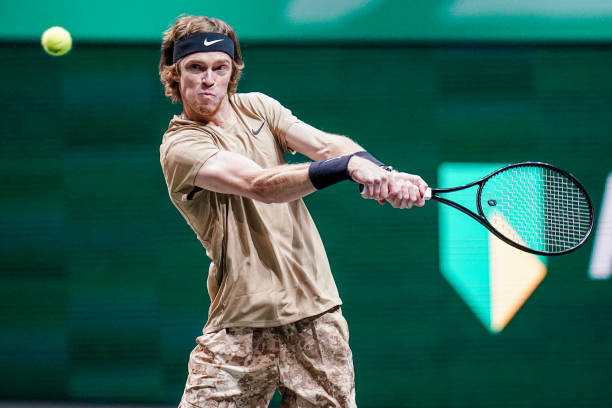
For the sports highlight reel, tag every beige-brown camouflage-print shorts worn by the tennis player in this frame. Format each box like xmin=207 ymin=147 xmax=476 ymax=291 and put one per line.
xmin=180 ymin=308 xmax=356 ymax=408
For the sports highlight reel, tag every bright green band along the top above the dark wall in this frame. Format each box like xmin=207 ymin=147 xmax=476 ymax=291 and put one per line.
xmin=0 ymin=0 xmax=612 ymax=42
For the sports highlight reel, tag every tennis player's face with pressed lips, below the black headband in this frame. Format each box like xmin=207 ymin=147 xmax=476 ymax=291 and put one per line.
xmin=179 ymin=51 xmax=232 ymax=122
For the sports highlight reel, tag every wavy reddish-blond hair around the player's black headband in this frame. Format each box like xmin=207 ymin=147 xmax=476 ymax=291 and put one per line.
xmin=159 ymin=15 xmax=244 ymax=103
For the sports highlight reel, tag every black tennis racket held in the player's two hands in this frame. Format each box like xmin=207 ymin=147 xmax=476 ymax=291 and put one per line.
xmin=425 ymin=162 xmax=594 ymax=255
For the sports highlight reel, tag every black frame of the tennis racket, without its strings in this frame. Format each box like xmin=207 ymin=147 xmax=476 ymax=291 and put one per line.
xmin=431 ymin=162 xmax=595 ymax=256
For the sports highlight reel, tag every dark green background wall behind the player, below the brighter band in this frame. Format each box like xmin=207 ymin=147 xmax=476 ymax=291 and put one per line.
xmin=0 ymin=37 xmax=612 ymax=407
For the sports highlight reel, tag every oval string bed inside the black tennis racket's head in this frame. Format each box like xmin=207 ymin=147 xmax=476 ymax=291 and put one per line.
xmin=481 ymin=166 xmax=592 ymax=253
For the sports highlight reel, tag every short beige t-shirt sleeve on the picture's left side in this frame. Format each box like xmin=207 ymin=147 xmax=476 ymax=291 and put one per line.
xmin=160 ymin=132 xmax=219 ymax=198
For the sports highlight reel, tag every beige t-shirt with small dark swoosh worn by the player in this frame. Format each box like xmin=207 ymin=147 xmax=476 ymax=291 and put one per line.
xmin=160 ymin=93 xmax=341 ymax=333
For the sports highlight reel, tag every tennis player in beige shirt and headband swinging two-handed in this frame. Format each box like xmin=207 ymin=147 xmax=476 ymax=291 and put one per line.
xmin=159 ymin=16 xmax=427 ymax=408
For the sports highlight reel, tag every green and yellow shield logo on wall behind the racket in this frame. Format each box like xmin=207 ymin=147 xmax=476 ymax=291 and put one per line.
xmin=438 ymin=163 xmax=547 ymax=333
